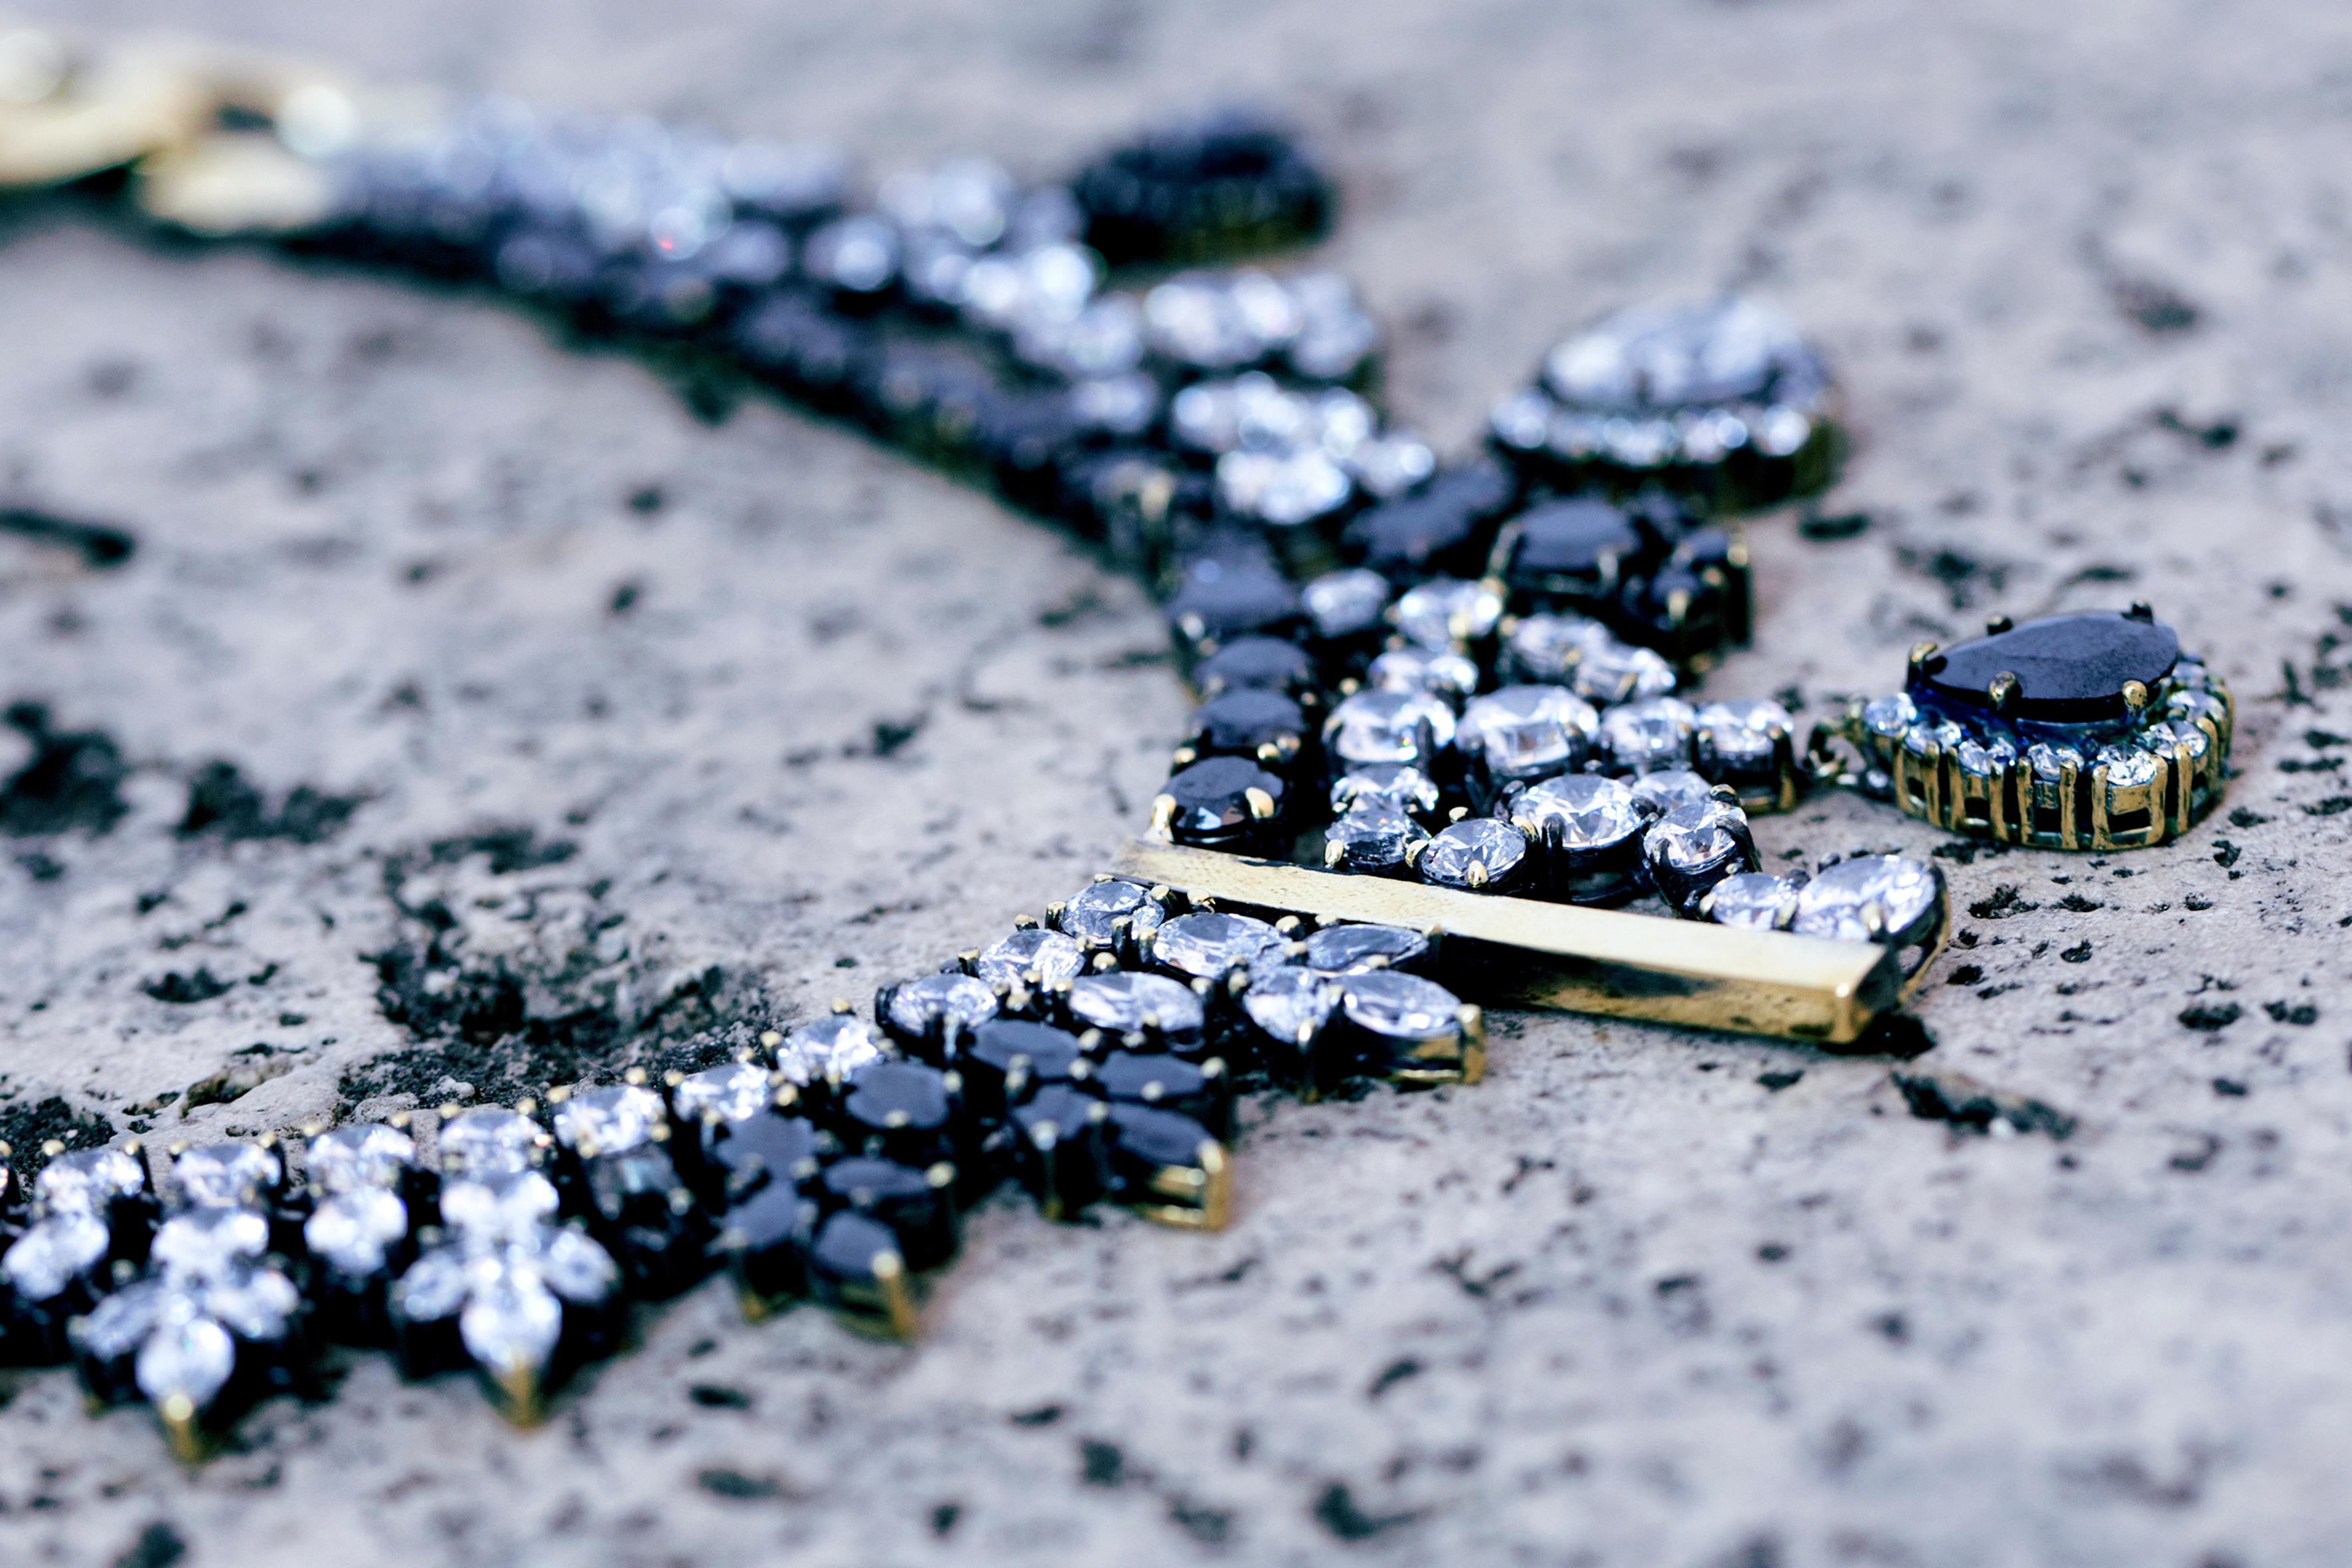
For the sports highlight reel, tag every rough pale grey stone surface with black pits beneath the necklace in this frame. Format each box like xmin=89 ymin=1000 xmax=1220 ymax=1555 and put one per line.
xmin=0 ymin=0 xmax=2352 ymax=1568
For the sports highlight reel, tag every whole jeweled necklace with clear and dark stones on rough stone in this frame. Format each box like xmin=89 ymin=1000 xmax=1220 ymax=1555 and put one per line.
xmin=0 ymin=24 xmax=2232 ymax=1458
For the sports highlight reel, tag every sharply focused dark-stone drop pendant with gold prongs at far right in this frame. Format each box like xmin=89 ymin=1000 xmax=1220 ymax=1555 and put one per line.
xmin=1806 ymin=604 xmax=2234 ymax=851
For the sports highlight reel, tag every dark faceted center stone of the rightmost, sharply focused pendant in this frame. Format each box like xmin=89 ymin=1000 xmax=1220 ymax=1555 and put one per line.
xmin=1912 ymin=611 xmax=2180 ymax=722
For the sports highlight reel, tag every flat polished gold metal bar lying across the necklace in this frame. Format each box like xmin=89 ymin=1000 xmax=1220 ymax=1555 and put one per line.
xmin=1113 ymin=839 xmax=1903 ymax=1046
